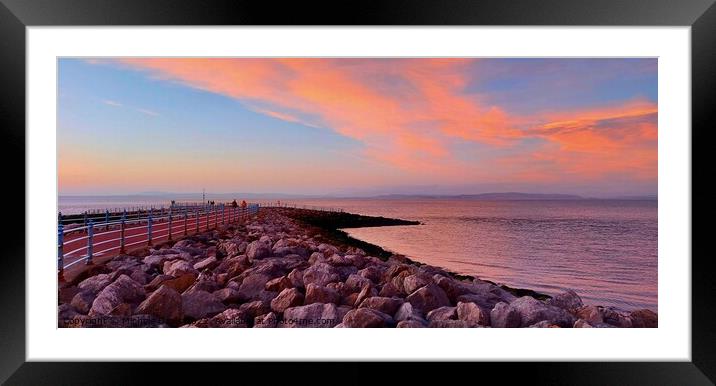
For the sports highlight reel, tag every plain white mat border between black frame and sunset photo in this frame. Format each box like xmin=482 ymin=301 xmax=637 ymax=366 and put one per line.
xmin=26 ymin=27 xmax=691 ymax=361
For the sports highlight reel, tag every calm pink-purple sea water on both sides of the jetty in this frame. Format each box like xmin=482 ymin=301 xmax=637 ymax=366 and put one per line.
xmin=59 ymin=196 xmax=658 ymax=311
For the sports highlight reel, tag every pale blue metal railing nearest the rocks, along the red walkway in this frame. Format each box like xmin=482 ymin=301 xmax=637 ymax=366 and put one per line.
xmin=57 ymin=204 xmax=259 ymax=274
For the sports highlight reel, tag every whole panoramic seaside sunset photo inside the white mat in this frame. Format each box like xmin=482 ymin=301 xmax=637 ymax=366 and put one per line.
xmin=57 ymin=56 xmax=656 ymax=328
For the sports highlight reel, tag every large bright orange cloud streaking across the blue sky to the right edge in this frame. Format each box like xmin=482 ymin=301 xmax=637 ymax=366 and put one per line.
xmin=96 ymin=58 xmax=657 ymax=187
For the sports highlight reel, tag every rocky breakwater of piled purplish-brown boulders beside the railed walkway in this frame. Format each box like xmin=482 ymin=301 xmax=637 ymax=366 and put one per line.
xmin=59 ymin=209 xmax=657 ymax=328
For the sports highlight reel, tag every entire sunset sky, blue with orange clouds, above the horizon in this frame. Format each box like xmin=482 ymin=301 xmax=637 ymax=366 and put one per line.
xmin=57 ymin=58 xmax=657 ymax=197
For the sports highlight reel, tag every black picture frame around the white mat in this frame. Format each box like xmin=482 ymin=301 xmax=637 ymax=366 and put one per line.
xmin=0 ymin=0 xmax=716 ymax=385
